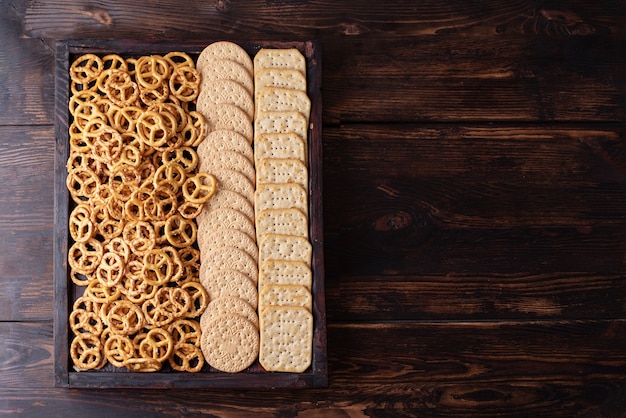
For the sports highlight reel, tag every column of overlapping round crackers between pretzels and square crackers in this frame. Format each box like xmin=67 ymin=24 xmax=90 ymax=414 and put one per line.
xmin=196 ymin=42 xmax=260 ymax=372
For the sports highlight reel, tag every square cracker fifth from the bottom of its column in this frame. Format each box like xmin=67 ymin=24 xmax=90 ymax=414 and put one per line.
xmin=255 ymin=208 xmax=309 ymax=239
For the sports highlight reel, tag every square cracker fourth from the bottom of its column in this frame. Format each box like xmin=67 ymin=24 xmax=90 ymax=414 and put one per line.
xmin=255 ymin=234 xmax=313 ymax=266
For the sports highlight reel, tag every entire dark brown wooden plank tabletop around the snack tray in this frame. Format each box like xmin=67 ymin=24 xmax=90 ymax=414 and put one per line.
xmin=0 ymin=0 xmax=626 ymax=417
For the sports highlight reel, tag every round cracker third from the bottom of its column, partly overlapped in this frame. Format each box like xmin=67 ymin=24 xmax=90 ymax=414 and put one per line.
xmin=201 ymin=269 xmax=258 ymax=309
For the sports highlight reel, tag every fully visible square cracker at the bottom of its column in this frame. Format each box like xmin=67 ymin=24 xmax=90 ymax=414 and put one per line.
xmin=259 ymin=306 xmax=313 ymax=373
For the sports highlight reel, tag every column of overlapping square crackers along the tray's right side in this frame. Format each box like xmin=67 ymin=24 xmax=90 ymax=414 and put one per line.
xmin=254 ymin=49 xmax=313 ymax=373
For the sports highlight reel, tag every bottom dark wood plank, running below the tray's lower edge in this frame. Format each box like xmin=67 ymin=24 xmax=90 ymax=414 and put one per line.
xmin=0 ymin=320 xmax=626 ymax=417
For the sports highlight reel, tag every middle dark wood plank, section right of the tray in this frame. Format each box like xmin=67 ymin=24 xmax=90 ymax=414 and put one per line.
xmin=324 ymin=125 xmax=626 ymax=320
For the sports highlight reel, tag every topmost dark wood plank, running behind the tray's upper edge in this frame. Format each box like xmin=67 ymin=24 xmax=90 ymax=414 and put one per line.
xmin=0 ymin=0 xmax=626 ymax=124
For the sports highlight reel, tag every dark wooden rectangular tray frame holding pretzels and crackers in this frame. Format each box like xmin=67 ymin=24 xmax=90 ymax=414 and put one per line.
xmin=54 ymin=40 xmax=328 ymax=388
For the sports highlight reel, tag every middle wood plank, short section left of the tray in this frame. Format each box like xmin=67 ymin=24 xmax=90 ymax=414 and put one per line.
xmin=0 ymin=126 xmax=54 ymax=321
